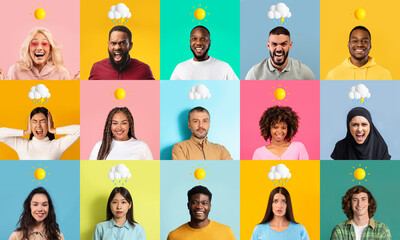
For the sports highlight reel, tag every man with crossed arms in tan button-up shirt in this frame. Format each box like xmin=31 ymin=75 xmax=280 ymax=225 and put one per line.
xmin=172 ymin=107 xmax=232 ymax=160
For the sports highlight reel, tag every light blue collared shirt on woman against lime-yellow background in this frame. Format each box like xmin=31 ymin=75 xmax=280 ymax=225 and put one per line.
xmin=92 ymin=218 xmax=146 ymax=240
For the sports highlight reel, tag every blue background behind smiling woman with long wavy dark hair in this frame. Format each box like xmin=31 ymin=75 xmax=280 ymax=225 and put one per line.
xmin=0 ymin=160 xmax=80 ymax=239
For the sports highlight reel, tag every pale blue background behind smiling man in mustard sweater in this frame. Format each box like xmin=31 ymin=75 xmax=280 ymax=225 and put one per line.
xmin=160 ymin=161 xmax=240 ymax=239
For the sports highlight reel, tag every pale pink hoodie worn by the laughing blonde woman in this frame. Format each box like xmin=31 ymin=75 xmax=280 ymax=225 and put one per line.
xmin=8 ymin=63 xmax=71 ymax=80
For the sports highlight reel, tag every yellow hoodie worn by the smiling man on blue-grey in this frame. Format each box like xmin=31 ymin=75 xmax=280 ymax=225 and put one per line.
xmin=326 ymin=57 xmax=392 ymax=80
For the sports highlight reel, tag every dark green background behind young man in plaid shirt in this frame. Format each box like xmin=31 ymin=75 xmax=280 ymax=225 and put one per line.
xmin=320 ymin=160 xmax=400 ymax=239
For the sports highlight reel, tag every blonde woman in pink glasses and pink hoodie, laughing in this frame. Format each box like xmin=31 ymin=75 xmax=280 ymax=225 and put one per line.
xmin=5 ymin=27 xmax=79 ymax=80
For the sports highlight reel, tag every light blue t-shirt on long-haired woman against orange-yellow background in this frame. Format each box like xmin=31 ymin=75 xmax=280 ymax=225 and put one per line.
xmin=251 ymin=222 xmax=310 ymax=240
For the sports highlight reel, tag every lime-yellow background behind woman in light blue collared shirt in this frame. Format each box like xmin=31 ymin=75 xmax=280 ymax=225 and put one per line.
xmin=80 ymin=160 xmax=160 ymax=239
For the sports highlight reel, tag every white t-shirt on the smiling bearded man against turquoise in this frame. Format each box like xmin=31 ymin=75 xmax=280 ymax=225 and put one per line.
xmin=171 ymin=57 xmax=239 ymax=80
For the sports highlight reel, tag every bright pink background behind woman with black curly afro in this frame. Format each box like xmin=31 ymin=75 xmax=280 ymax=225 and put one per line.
xmin=240 ymin=80 xmax=319 ymax=160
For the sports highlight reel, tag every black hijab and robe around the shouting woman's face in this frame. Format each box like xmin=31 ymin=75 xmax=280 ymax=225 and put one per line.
xmin=331 ymin=107 xmax=391 ymax=160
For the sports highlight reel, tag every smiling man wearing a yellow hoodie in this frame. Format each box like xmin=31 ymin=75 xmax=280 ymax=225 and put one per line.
xmin=326 ymin=26 xmax=392 ymax=80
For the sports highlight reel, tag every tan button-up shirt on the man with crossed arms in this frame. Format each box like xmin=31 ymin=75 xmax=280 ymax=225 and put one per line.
xmin=172 ymin=135 xmax=232 ymax=160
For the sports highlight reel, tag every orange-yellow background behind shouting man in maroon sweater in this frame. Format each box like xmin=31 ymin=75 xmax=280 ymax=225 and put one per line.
xmin=81 ymin=0 xmax=160 ymax=80
